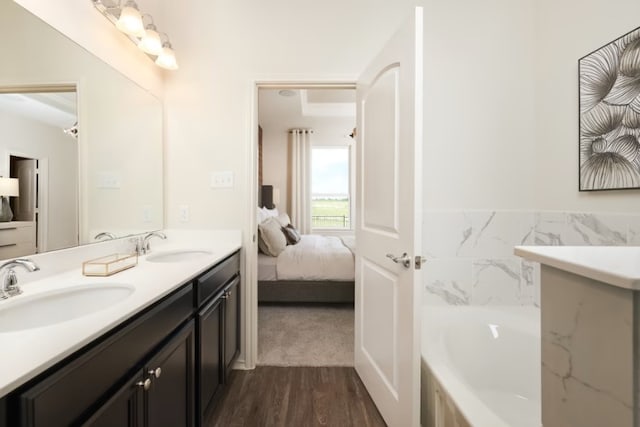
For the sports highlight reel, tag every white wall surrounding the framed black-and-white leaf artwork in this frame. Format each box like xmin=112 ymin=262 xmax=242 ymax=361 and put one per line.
xmin=535 ymin=0 xmax=640 ymax=213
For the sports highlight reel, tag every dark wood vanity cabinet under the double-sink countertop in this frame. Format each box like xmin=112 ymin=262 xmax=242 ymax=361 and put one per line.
xmin=0 ymin=252 xmax=241 ymax=427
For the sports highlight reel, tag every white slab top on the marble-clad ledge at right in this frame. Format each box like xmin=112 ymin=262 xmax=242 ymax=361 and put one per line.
xmin=514 ymin=246 xmax=640 ymax=290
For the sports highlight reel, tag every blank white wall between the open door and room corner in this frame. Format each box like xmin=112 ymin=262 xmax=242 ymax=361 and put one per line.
xmin=424 ymin=0 xmax=536 ymax=209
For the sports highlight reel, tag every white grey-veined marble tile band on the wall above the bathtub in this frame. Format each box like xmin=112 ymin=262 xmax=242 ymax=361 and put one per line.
xmin=423 ymin=210 xmax=640 ymax=306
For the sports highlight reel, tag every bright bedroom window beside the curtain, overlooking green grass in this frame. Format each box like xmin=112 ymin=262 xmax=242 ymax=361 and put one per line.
xmin=311 ymin=146 xmax=351 ymax=230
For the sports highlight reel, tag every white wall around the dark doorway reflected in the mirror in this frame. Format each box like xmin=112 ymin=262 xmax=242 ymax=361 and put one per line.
xmin=0 ymin=111 xmax=78 ymax=250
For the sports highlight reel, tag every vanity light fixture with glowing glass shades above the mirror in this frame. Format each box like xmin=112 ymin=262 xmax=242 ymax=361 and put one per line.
xmin=91 ymin=0 xmax=178 ymax=70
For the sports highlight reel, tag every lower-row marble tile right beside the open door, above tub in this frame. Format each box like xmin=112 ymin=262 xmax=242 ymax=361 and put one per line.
xmin=423 ymin=258 xmax=472 ymax=305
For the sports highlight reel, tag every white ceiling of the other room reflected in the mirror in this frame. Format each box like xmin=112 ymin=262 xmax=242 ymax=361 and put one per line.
xmin=0 ymin=92 xmax=77 ymax=129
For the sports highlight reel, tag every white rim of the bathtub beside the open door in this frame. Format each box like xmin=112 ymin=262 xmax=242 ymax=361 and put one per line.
xmin=422 ymin=306 xmax=539 ymax=427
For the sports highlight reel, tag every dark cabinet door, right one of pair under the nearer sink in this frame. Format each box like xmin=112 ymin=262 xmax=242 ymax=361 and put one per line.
xmin=145 ymin=320 xmax=195 ymax=427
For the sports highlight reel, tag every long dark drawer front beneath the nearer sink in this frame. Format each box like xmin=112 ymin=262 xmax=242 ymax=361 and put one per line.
xmin=19 ymin=285 xmax=193 ymax=427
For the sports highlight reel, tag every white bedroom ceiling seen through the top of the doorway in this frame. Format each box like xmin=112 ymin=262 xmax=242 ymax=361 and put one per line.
xmin=258 ymin=88 xmax=356 ymax=136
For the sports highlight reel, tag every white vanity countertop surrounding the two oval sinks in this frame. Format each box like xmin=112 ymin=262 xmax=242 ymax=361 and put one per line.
xmin=0 ymin=232 xmax=241 ymax=398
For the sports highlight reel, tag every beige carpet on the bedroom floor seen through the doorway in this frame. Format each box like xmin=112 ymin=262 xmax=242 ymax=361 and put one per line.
xmin=258 ymin=305 xmax=354 ymax=366
